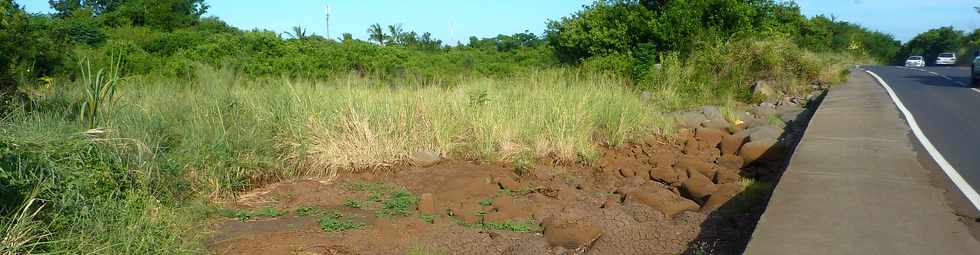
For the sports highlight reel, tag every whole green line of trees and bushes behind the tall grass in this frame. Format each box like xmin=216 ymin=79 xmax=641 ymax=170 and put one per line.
xmin=0 ymin=0 xmax=900 ymax=101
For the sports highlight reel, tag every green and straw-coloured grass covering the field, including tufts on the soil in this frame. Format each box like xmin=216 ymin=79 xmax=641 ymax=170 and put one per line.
xmin=0 ymin=36 xmax=849 ymax=254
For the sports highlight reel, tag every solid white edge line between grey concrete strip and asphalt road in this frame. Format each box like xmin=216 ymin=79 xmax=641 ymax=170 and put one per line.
xmin=862 ymin=69 xmax=980 ymax=210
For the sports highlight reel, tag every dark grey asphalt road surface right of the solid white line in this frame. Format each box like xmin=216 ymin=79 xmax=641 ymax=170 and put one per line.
xmin=864 ymin=66 xmax=980 ymax=194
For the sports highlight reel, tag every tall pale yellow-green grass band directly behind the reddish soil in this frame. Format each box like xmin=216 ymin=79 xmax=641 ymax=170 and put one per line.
xmin=101 ymin=66 xmax=672 ymax=190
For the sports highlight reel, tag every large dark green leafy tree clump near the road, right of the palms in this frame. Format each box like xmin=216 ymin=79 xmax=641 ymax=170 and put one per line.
xmin=547 ymin=0 xmax=899 ymax=72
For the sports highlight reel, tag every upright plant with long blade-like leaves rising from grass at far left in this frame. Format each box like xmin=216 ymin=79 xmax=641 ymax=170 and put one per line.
xmin=79 ymin=57 xmax=122 ymax=129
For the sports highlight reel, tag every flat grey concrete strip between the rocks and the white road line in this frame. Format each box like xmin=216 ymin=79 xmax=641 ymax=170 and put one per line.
xmin=745 ymin=70 xmax=980 ymax=255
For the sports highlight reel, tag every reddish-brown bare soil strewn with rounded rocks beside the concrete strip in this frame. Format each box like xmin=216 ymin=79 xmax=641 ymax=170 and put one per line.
xmin=207 ymin=126 xmax=796 ymax=254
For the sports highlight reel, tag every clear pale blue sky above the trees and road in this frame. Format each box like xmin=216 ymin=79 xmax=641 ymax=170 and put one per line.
xmin=15 ymin=0 xmax=980 ymax=43
